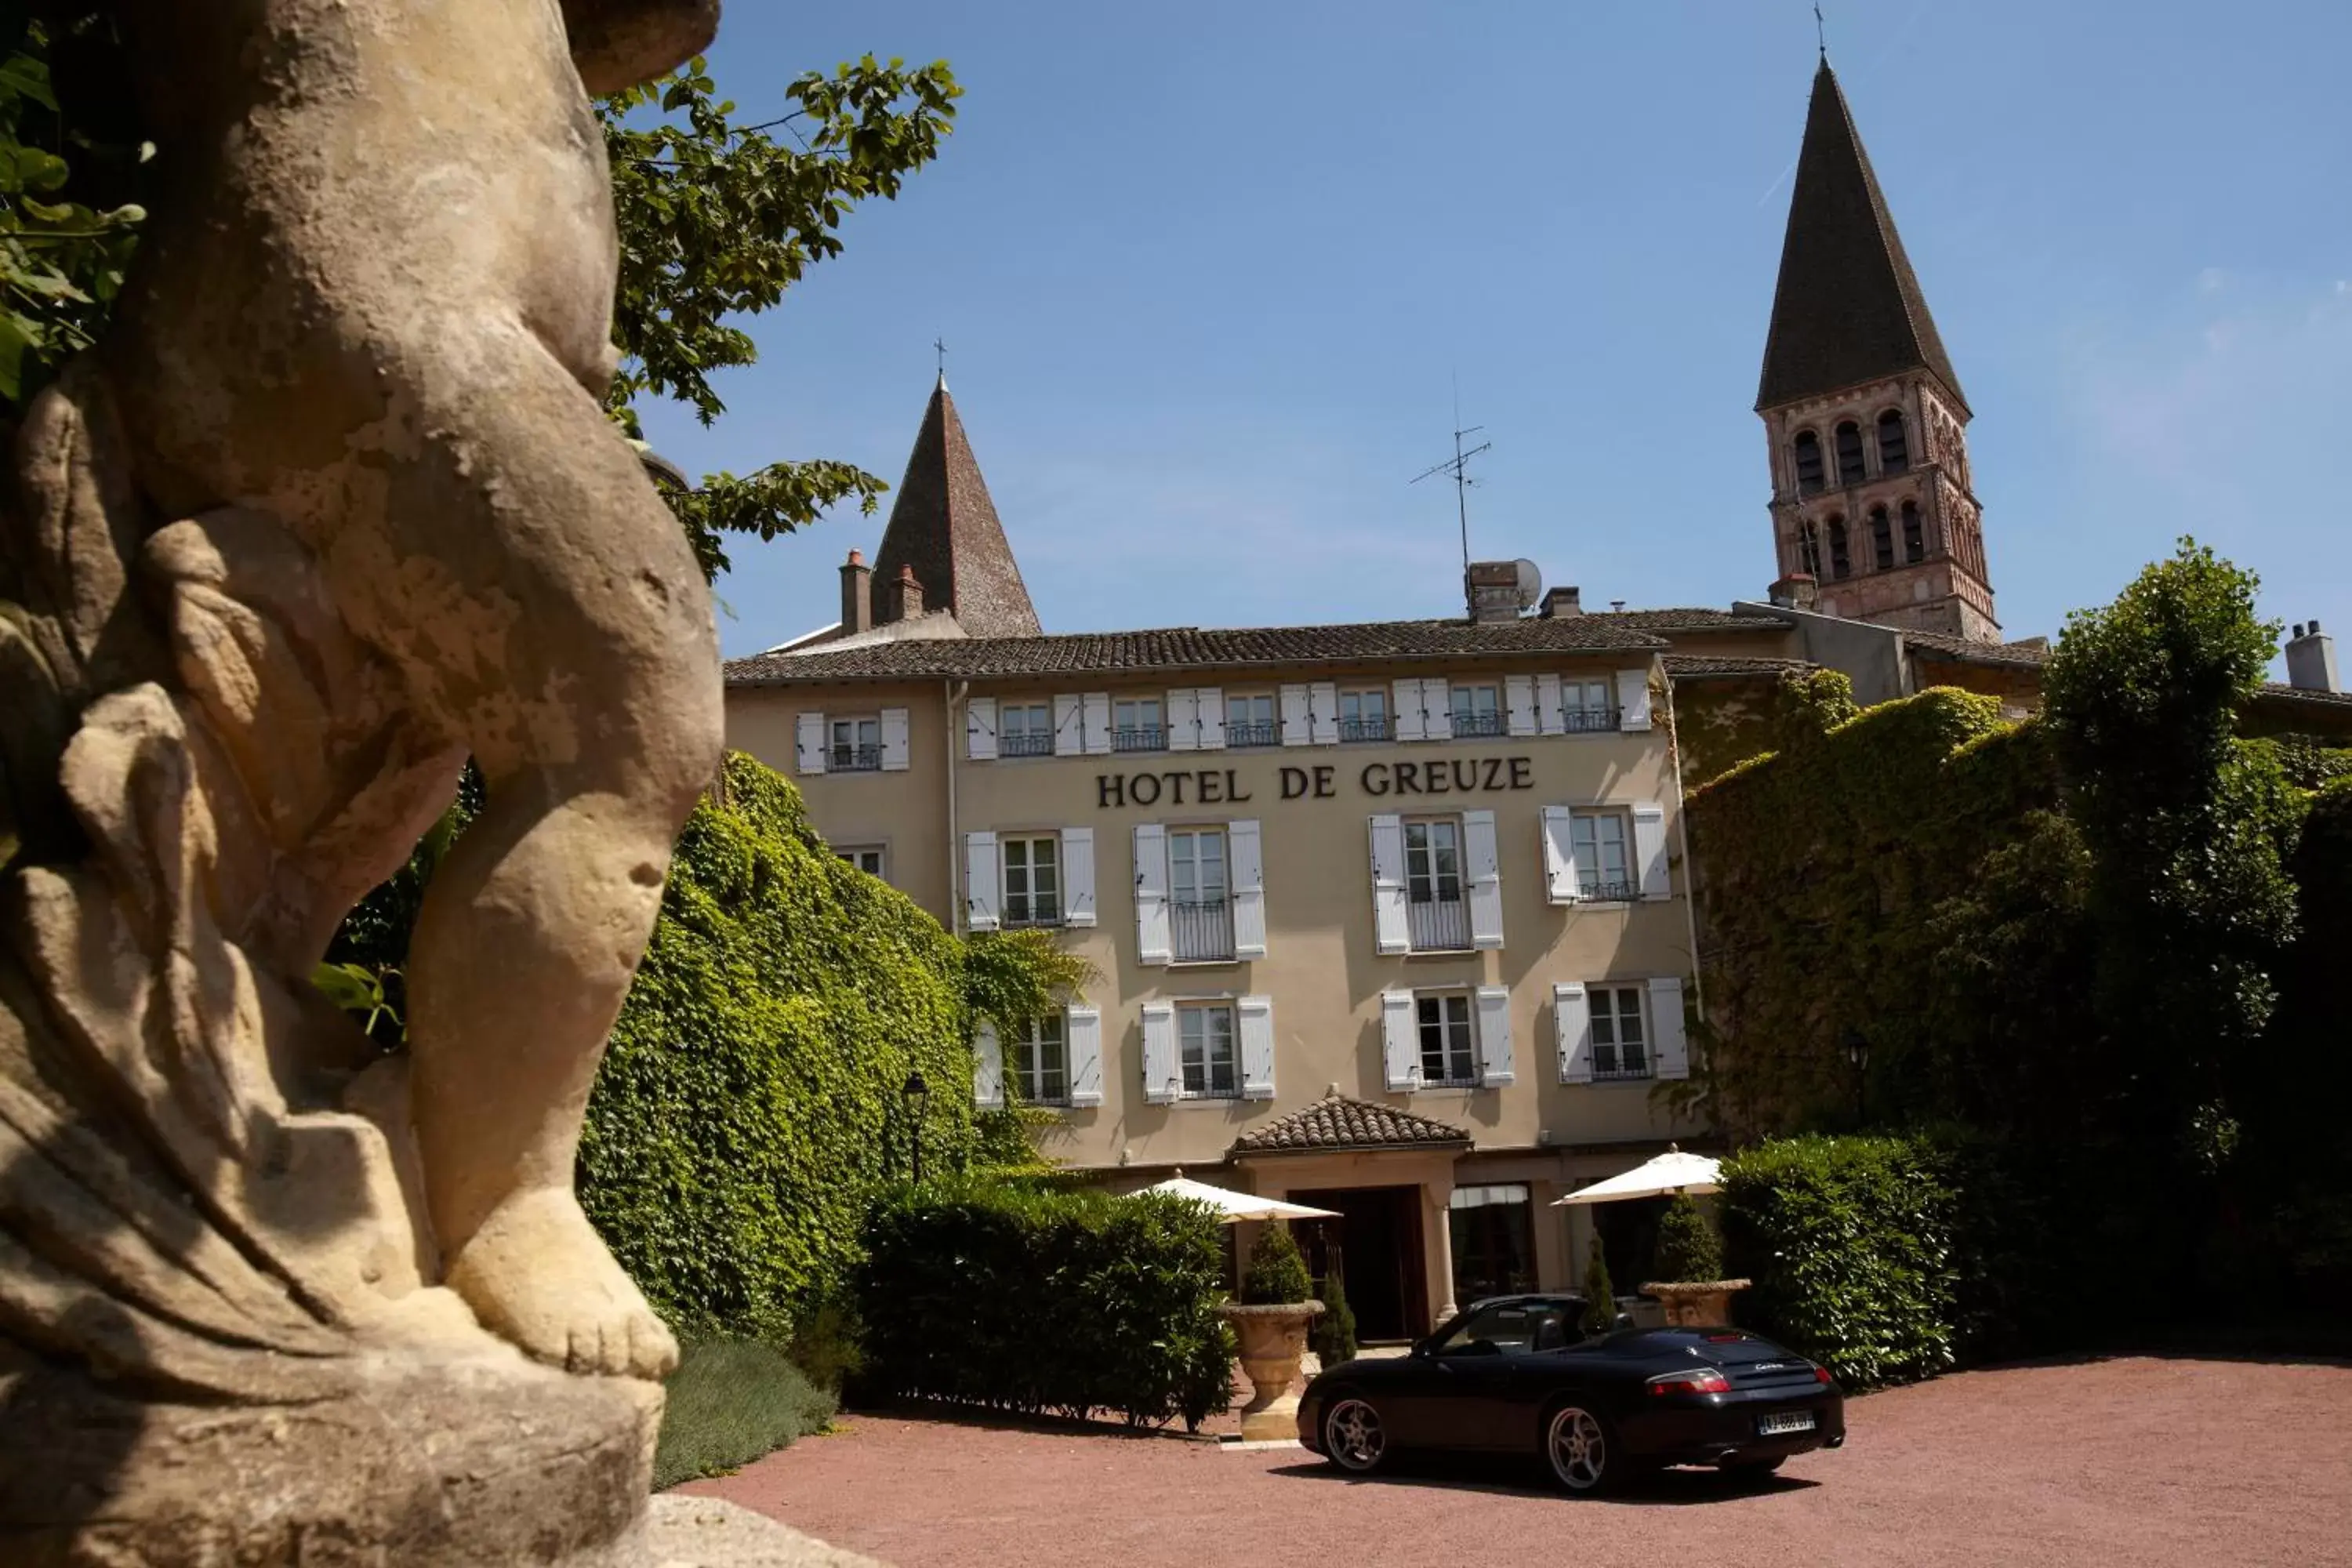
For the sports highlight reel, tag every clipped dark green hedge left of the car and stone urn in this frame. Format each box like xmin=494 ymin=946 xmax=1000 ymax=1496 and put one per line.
xmin=856 ymin=1178 xmax=1232 ymax=1427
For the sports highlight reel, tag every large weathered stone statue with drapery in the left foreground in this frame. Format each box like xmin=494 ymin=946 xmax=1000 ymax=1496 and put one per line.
xmin=0 ymin=0 xmax=800 ymax=1566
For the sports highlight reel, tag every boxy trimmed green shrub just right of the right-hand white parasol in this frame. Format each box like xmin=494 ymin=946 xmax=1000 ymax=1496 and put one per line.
xmin=1724 ymin=1138 xmax=1959 ymax=1387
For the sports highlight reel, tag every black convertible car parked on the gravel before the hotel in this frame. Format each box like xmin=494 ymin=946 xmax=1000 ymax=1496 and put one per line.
xmin=1298 ymin=1295 xmax=1846 ymax=1493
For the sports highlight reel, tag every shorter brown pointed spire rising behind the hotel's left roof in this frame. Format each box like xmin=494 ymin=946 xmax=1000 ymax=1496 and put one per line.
xmin=873 ymin=372 xmax=1040 ymax=637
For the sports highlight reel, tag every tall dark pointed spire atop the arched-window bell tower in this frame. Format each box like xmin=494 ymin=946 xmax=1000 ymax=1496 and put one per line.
xmin=1757 ymin=56 xmax=1966 ymax=409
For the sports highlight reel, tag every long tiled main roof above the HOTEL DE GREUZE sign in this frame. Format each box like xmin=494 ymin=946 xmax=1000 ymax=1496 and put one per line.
xmin=727 ymin=616 xmax=1668 ymax=687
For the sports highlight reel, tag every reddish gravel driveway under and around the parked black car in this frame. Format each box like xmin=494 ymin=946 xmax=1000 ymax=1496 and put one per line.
xmin=682 ymin=1359 xmax=2352 ymax=1568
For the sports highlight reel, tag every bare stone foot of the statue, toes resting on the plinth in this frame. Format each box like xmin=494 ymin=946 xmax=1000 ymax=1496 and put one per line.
xmin=449 ymin=1187 xmax=677 ymax=1380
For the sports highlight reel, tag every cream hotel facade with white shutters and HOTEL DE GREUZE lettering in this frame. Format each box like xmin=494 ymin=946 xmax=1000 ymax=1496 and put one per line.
xmin=729 ymin=644 xmax=1703 ymax=1338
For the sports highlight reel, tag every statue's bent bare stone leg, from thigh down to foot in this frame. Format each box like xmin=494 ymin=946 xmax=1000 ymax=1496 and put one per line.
xmin=327 ymin=329 xmax=722 ymax=1377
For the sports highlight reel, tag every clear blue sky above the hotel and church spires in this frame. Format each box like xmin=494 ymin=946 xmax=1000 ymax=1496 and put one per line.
xmin=649 ymin=0 xmax=2352 ymax=654
